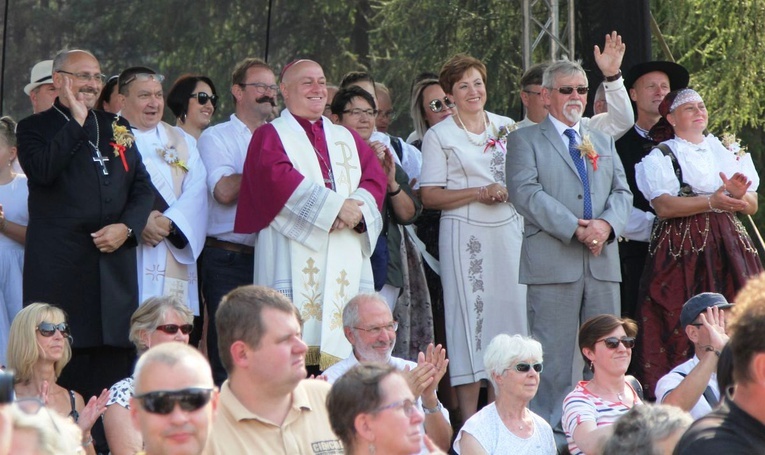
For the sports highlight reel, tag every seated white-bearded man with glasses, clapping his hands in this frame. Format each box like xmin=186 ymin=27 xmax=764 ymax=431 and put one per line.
xmin=324 ymin=294 xmax=452 ymax=453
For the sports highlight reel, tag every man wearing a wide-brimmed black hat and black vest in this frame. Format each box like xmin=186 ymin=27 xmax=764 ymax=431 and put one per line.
xmin=616 ymin=61 xmax=689 ymax=319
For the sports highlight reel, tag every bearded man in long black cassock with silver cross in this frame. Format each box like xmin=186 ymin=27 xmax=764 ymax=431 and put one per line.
xmin=17 ymin=50 xmax=154 ymax=401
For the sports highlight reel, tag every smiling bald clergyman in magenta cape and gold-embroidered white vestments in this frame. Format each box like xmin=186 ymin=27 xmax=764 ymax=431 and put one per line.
xmin=234 ymin=60 xmax=387 ymax=370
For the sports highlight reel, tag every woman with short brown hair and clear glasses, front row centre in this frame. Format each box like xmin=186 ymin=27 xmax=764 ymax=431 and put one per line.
xmin=327 ymin=363 xmax=445 ymax=455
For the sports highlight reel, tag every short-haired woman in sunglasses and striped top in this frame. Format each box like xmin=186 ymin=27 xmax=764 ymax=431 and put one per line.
xmin=561 ymin=314 xmax=643 ymax=455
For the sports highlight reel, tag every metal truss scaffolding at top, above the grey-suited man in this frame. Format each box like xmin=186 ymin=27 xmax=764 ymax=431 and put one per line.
xmin=521 ymin=0 xmax=576 ymax=70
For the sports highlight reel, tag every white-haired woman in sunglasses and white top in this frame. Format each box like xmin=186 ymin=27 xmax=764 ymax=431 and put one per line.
xmin=454 ymin=334 xmax=557 ymax=455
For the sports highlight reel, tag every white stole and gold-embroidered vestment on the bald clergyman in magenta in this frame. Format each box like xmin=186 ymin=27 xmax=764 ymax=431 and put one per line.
xmin=254 ymin=110 xmax=382 ymax=370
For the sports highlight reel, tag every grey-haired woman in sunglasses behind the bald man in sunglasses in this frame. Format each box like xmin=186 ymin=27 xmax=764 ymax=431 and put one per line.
xmin=104 ymin=296 xmax=194 ymax=455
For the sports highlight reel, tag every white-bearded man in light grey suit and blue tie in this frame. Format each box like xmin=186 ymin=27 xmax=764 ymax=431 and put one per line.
xmin=507 ymin=60 xmax=632 ymax=427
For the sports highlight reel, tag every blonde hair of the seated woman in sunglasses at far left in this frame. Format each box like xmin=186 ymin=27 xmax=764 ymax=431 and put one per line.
xmin=6 ymin=303 xmax=72 ymax=383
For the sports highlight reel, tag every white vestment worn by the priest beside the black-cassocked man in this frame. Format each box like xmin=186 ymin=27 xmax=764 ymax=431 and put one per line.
xmin=133 ymin=122 xmax=207 ymax=315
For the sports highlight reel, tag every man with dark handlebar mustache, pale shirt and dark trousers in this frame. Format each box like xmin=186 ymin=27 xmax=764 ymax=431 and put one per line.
xmin=197 ymin=58 xmax=279 ymax=385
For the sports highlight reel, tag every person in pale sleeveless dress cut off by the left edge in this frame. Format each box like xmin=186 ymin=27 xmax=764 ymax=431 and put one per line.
xmin=0 ymin=117 xmax=29 ymax=365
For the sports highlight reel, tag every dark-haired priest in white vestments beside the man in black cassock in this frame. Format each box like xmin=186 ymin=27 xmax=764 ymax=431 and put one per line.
xmin=118 ymin=66 xmax=207 ymax=330
